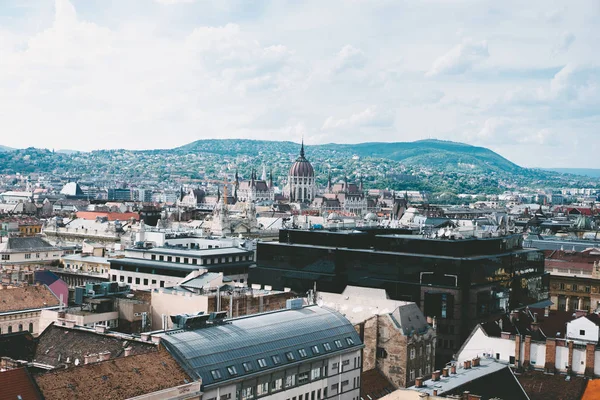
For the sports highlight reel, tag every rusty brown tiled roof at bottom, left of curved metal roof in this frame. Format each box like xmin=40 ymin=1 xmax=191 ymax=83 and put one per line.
xmin=36 ymin=350 xmax=191 ymax=400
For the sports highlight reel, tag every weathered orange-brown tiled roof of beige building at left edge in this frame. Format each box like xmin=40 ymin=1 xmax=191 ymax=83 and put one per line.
xmin=0 ymin=285 xmax=60 ymax=313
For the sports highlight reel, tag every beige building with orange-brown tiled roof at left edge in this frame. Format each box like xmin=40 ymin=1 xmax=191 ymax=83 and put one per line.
xmin=0 ymin=285 xmax=60 ymax=336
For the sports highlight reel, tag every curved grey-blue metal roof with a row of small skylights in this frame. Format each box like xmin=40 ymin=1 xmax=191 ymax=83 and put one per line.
xmin=161 ymin=306 xmax=363 ymax=387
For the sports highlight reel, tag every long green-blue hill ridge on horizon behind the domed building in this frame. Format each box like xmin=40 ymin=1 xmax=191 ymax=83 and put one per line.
xmin=174 ymin=139 xmax=523 ymax=173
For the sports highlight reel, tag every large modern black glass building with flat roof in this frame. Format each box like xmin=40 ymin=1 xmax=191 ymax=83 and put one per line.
xmin=249 ymin=230 xmax=549 ymax=364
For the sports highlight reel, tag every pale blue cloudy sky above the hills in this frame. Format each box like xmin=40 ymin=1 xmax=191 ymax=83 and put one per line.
xmin=0 ymin=0 xmax=600 ymax=168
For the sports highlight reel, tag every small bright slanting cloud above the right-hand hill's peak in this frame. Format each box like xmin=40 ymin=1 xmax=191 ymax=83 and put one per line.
xmin=425 ymin=39 xmax=490 ymax=77
